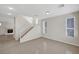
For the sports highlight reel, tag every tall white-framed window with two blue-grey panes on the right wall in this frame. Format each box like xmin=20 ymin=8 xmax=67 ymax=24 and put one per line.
xmin=66 ymin=17 xmax=75 ymax=38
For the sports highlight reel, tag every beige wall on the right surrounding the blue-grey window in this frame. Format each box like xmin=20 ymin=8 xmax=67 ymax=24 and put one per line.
xmin=43 ymin=11 xmax=79 ymax=46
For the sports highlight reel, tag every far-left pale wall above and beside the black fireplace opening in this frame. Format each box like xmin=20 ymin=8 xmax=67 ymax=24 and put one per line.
xmin=0 ymin=16 xmax=14 ymax=35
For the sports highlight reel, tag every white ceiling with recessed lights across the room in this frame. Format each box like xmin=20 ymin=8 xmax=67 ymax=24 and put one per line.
xmin=0 ymin=4 xmax=79 ymax=19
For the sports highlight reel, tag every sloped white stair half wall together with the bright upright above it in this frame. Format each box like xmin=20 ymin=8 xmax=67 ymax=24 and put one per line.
xmin=20 ymin=15 xmax=42 ymax=43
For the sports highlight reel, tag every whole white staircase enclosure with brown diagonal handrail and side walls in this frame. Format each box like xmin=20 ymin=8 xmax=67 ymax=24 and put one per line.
xmin=15 ymin=16 xmax=41 ymax=43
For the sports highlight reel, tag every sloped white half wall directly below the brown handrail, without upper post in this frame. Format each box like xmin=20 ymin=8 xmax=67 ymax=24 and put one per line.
xmin=20 ymin=25 xmax=41 ymax=43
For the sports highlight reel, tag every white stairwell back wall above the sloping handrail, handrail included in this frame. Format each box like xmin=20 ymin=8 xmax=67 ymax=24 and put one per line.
xmin=14 ymin=16 xmax=33 ymax=40
